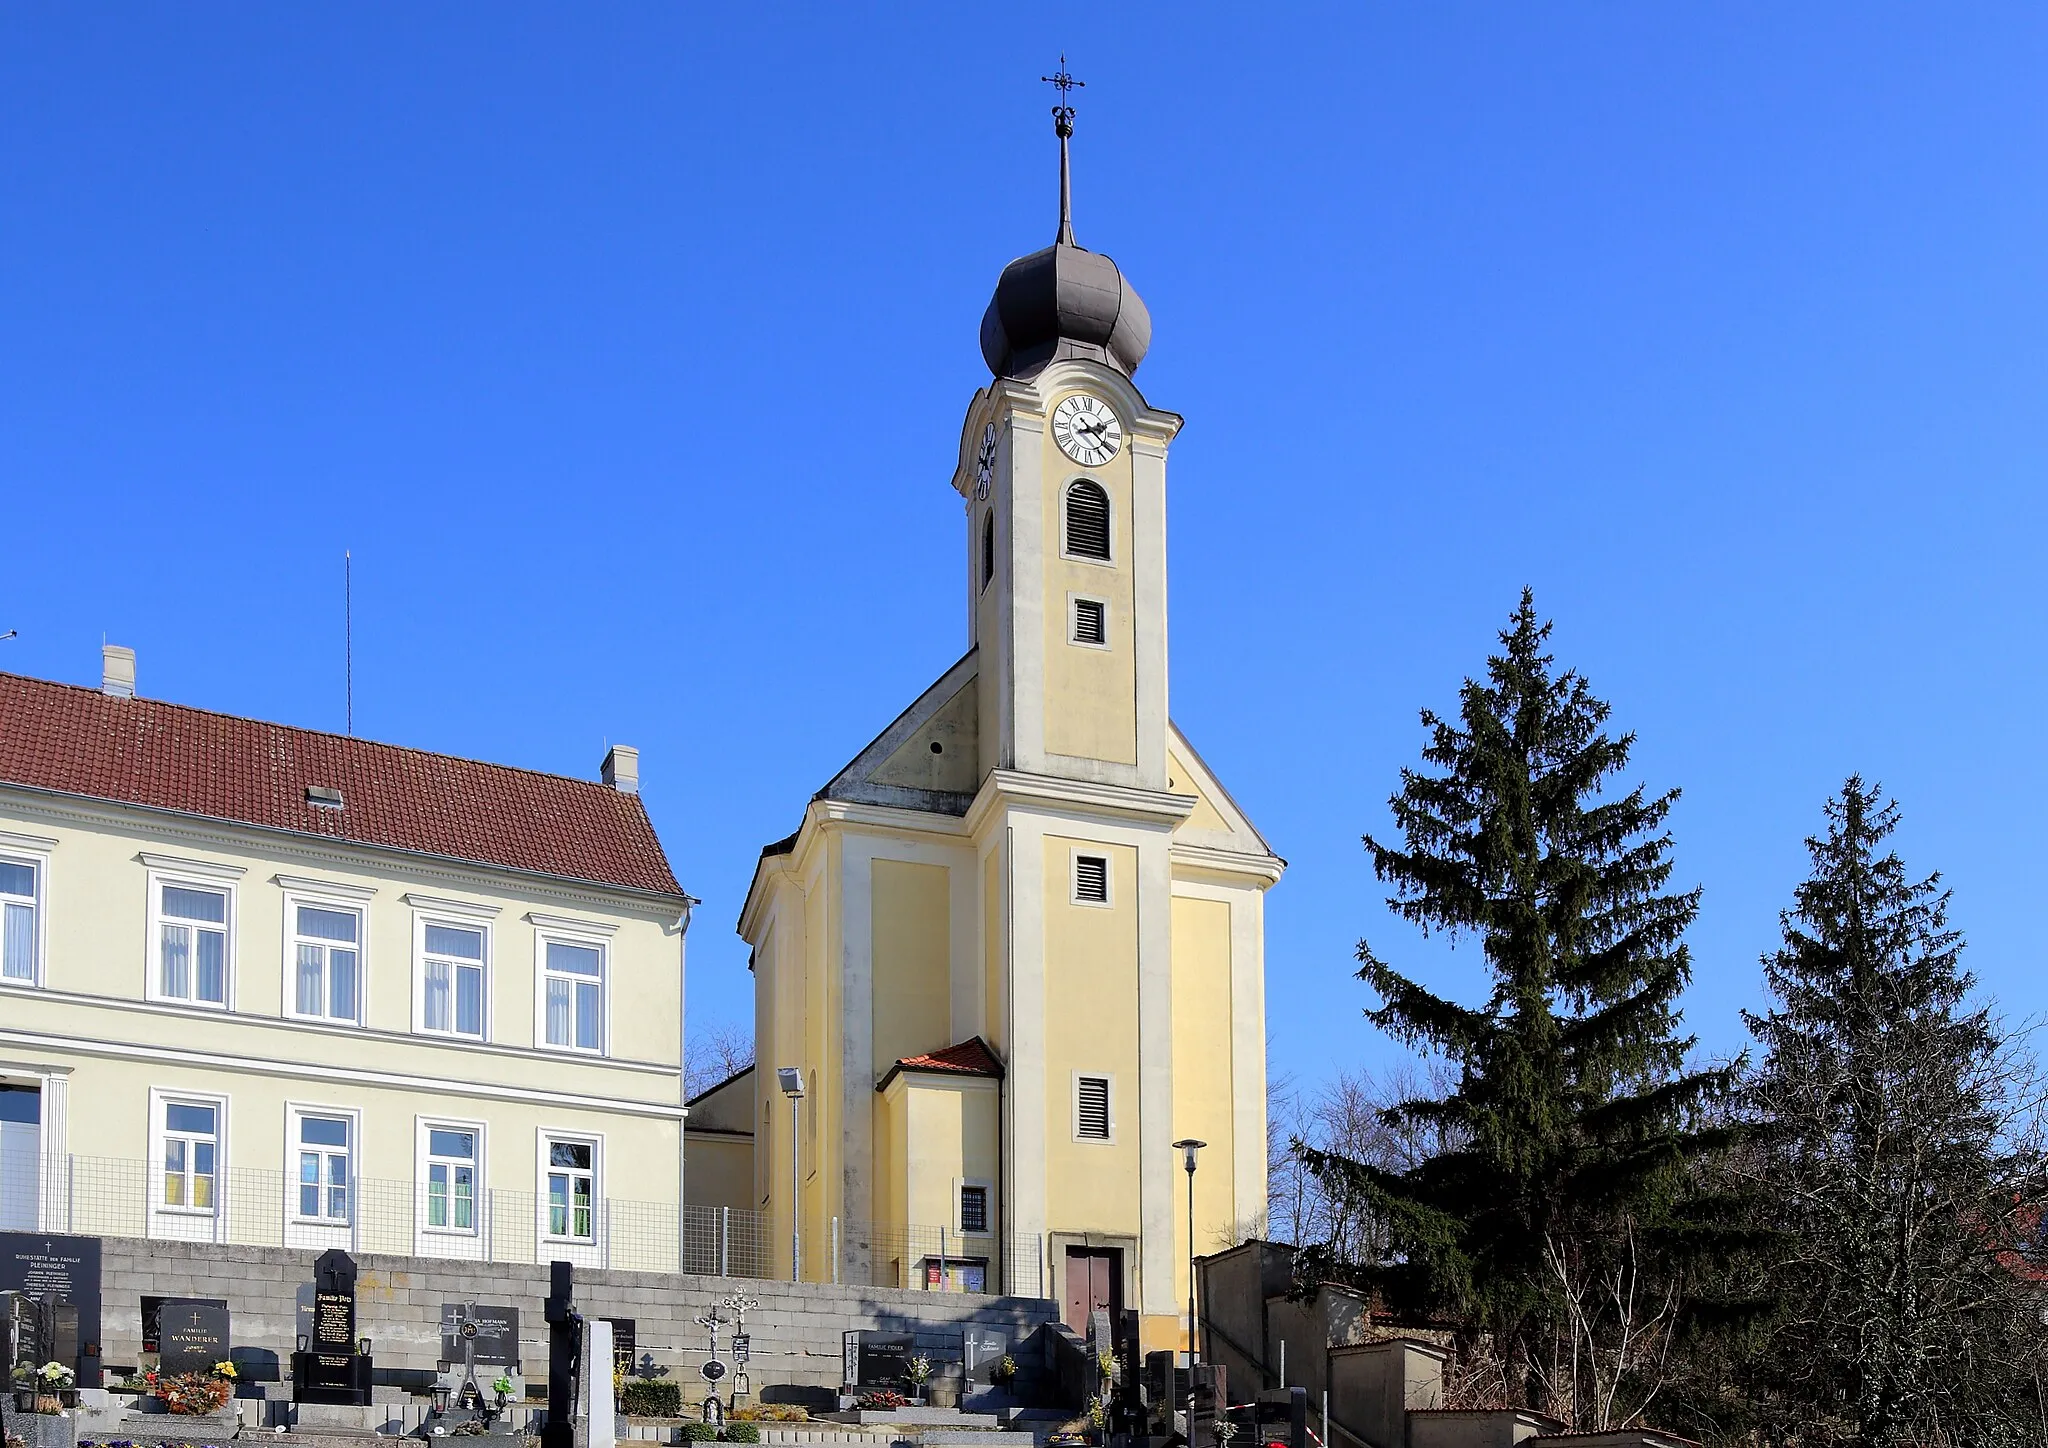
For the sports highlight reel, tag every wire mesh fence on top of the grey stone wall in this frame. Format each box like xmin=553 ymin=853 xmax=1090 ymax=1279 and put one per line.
xmin=29 ymin=1155 xmax=1044 ymax=1296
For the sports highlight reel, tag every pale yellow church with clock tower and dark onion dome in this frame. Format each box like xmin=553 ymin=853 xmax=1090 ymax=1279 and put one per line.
xmin=688 ymin=87 xmax=1284 ymax=1348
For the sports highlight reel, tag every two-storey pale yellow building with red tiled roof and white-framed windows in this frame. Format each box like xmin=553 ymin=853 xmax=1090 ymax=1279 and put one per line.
xmin=0 ymin=649 xmax=694 ymax=1268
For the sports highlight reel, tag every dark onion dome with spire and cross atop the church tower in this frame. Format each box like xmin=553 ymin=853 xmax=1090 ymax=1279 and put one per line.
xmin=981 ymin=55 xmax=1151 ymax=377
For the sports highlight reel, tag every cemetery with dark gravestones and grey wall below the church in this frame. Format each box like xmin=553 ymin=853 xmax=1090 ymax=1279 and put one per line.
xmin=0 ymin=1233 xmax=1683 ymax=1448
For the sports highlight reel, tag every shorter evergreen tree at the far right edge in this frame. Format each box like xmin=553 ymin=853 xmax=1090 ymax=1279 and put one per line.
xmin=1743 ymin=776 xmax=2048 ymax=1448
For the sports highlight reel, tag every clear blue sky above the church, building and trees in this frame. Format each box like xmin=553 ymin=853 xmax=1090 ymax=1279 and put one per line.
xmin=0 ymin=4 xmax=2048 ymax=1081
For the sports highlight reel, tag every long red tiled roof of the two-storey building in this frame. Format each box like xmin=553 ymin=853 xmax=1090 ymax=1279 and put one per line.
xmin=0 ymin=674 xmax=682 ymax=895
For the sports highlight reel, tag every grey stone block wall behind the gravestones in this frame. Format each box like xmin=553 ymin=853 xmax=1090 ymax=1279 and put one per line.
xmin=100 ymin=1237 xmax=1059 ymax=1401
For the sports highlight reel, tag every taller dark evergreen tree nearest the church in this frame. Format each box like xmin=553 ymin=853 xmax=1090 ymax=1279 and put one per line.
xmin=1303 ymin=590 xmax=1729 ymax=1425
